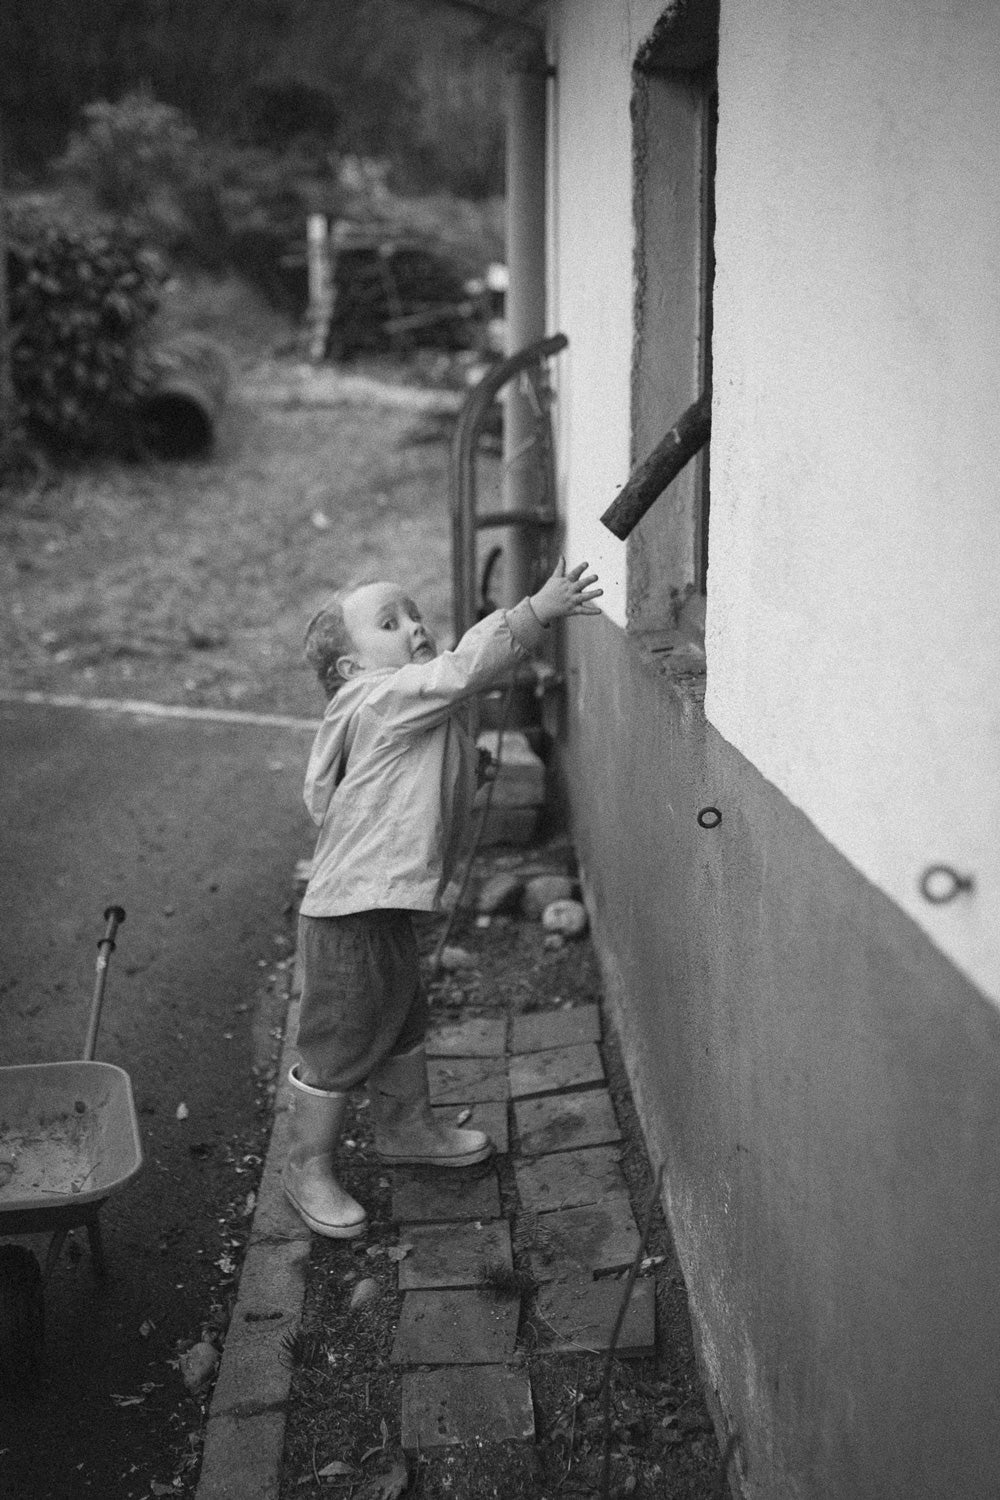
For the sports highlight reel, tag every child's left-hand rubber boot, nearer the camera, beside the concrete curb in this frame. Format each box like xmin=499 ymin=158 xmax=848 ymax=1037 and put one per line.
xmin=282 ymin=1068 xmax=367 ymax=1239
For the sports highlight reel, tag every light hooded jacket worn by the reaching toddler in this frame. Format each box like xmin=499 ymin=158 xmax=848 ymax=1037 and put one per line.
xmin=300 ymin=599 xmax=543 ymax=917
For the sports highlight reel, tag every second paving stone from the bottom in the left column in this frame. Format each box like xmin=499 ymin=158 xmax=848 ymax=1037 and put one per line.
xmin=390 ymin=1292 xmax=520 ymax=1365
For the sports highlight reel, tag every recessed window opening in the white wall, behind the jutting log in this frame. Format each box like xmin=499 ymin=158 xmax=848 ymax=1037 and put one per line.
xmin=627 ymin=0 xmax=718 ymax=648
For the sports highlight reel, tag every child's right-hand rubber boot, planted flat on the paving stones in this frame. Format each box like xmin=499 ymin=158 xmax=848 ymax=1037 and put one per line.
xmin=367 ymin=1047 xmax=493 ymax=1167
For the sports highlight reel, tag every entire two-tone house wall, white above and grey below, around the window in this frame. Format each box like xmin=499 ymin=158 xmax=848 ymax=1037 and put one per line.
xmin=549 ymin=0 xmax=1000 ymax=1500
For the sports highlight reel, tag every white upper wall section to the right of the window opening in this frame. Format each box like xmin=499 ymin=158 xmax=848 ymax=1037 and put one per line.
xmin=706 ymin=0 xmax=1000 ymax=999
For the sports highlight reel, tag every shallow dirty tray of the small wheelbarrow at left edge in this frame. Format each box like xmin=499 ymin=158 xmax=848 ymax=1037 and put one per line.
xmin=0 ymin=1062 xmax=142 ymax=1235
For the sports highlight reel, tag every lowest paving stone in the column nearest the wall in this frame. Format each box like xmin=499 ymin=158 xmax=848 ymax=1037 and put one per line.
xmin=537 ymin=1277 xmax=657 ymax=1359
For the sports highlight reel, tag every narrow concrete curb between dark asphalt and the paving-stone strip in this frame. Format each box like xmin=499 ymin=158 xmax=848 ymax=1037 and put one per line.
xmin=195 ymin=999 xmax=312 ymax=1500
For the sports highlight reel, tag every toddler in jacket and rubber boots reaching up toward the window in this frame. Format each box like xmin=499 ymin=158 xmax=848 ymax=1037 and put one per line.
xmin=282 ymin=561 xmax=601 ymax=1239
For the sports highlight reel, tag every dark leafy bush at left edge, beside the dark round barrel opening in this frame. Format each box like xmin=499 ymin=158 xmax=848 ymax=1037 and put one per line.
xmin=9 ymin=214 xmax=163 ymax=452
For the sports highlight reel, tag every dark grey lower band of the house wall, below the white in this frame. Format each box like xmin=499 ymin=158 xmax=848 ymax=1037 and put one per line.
xmin=568 ymin=621 xmax=1000 ymax=1500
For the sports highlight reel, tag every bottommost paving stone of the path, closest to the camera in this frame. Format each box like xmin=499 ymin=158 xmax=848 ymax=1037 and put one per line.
xmin=402 ymin=1365 xmax=535 ymax=1454
